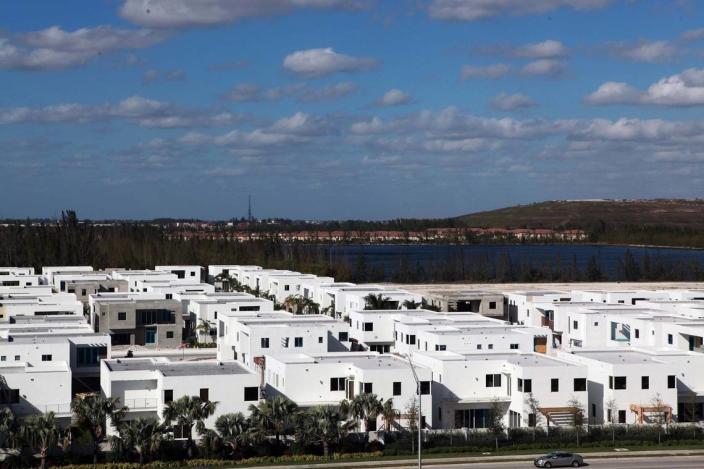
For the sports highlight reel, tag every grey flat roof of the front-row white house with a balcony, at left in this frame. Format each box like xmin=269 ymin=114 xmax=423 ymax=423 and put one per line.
xmin=105 ymin=358 xmax=254 ymax=376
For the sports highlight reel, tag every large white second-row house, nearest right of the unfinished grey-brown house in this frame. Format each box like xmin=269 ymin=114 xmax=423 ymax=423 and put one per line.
xmin=217 ymin=311 xmax=349 ymax=369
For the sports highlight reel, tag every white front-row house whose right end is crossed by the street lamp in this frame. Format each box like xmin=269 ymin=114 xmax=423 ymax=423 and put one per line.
xmin=264 ymin=352 xmax=434 ymax=430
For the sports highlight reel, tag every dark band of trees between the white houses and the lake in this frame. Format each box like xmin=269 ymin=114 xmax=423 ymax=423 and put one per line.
xmin=0 ymin=211 xmax=704 ymax=283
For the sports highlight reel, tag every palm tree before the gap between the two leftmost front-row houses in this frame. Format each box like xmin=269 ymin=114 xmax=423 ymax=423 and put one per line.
xmin=71 ymin=394 xmax=128 ymax=465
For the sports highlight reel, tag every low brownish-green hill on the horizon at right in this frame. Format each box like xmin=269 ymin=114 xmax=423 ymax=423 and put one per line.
xmin=458 ymin=199 xmax=704 ymax=229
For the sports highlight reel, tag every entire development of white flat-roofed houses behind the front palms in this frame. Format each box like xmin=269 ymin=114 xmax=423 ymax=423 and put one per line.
xmin=0 ymin=265 xmax=704 ymax=430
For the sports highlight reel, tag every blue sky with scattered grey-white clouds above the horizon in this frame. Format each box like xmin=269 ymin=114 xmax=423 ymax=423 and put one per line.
xmin=0 ymin=0 xmax=704 ymax=219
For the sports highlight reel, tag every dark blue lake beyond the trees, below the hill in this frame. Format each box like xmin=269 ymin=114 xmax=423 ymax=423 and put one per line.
xmin=326 ymin=244 xmax=704 ymax=281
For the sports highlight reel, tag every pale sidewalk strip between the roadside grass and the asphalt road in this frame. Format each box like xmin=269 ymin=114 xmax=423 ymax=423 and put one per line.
xmin=245 ymin=448 xmax=704 ymax=469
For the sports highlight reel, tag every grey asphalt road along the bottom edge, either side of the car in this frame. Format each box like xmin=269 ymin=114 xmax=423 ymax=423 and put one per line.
xmin=378 ymin=456 xmax=704 ymax=469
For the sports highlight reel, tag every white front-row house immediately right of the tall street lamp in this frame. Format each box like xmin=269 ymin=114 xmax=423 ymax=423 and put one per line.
xmin=413 ymin=351 xmax=588 ymax=429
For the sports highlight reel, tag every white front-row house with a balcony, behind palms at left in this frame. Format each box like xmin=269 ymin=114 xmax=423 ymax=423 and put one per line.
xmin=100 ymin=357 xmax=260 ymax=438
